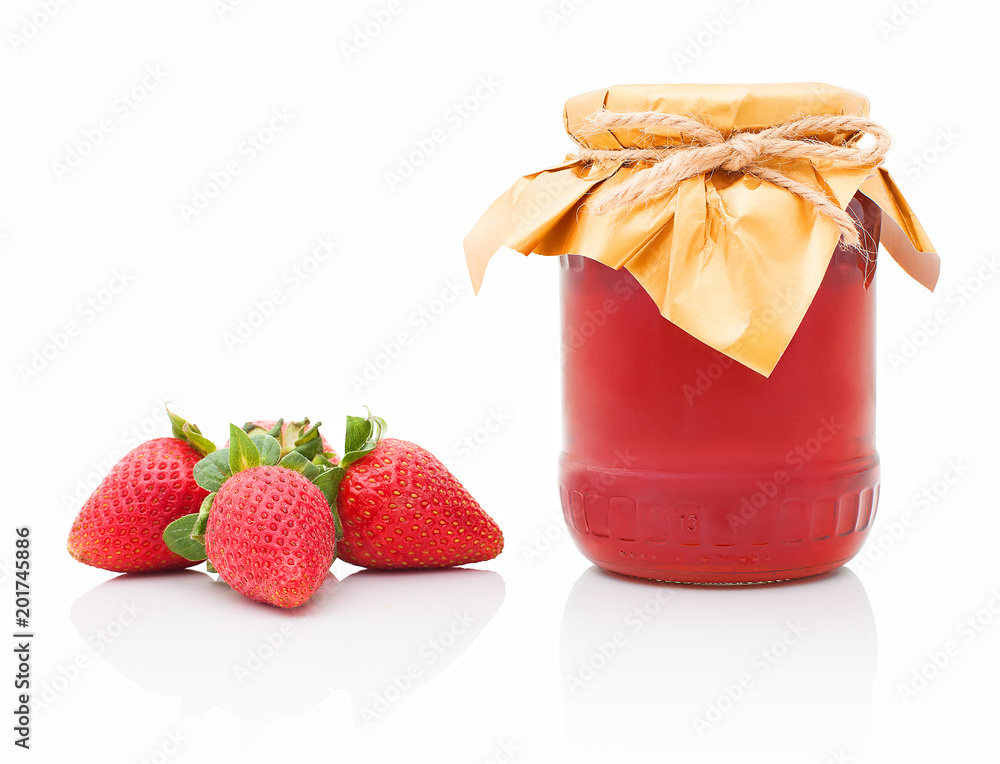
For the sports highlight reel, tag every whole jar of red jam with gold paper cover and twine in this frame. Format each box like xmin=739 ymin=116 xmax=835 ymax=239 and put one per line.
xmin=465 ymin=83 xmax=940 ymax=583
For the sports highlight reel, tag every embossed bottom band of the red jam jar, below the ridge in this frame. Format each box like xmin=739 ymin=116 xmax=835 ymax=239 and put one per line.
xmin=560 ymin=453 xmax=879 ymax=585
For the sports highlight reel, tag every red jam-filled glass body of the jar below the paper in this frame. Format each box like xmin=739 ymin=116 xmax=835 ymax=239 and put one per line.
xmin=560 ymin=195 xmax=881 ymax=583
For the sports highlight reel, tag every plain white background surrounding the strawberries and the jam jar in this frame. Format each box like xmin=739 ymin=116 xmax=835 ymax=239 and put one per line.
xmin=0 ymin=0 xmax=1000 ymax=764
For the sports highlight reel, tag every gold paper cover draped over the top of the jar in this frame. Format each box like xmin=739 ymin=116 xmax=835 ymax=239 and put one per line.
xmin=465 ymin=83 xmax=940 ymax=376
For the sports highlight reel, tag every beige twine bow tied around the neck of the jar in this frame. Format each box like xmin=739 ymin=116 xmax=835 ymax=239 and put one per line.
xmin=576 ymin=111 xmax=890 ymax=247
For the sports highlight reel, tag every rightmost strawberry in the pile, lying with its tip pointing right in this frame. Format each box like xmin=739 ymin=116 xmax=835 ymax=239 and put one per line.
xmin=336 ymin=417 xmax=503 ymax=569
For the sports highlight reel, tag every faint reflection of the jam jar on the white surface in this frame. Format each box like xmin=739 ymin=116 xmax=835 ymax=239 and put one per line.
xmin=559 ymin=567 xmax=878 ymax=764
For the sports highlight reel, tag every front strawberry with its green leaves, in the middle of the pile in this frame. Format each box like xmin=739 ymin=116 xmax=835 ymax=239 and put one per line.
xmin=164 ymin=425 xmax=338 ymax=608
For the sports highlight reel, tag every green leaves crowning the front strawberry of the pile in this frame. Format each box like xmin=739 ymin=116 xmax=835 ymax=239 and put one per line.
xmin=163 ymin=420 xmax=348 ymax=560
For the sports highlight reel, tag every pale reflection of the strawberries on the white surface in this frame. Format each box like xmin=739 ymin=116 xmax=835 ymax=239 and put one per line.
xmin=70 ymin=568 xmax=504 ymax=742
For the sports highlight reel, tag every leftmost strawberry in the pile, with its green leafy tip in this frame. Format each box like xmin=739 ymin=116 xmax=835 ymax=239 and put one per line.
xmin=67 ymin=409 xmax=215 ymax=573
